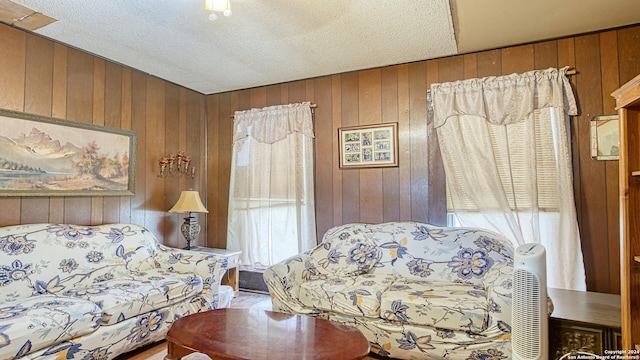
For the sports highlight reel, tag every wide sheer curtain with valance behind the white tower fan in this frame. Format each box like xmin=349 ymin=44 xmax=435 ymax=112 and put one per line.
xmin=431 ymin=68 xmax=586 ymax=290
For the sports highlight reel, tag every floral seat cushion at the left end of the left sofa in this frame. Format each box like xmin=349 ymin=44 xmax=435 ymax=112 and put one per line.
xmin=0 ymin=295 xmax=102 ymax=359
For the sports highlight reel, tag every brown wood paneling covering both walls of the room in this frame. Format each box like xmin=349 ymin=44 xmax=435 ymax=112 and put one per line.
xmin=0 ymin=21 xmax=640 ymax=293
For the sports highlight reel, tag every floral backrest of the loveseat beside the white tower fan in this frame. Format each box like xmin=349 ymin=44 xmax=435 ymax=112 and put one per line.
xmin=320 ymin=222 xmax=513 ymax=285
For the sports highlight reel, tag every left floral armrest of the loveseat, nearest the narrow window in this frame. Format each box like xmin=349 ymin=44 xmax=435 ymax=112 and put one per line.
xmin=263 ymin=252 xmax=326 ymax=314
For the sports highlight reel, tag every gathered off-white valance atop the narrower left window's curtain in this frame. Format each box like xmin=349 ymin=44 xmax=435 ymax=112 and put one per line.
xmin=233 ymin=101 xmax=313 ymax=144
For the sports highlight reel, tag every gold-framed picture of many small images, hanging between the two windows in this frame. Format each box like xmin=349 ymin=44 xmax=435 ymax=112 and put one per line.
xmin=338 ymin=123 xmax=398 ymax=169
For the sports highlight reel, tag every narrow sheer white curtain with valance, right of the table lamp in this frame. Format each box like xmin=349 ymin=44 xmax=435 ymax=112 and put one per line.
xmin=227 ymin=102 xmax=316 ymax=268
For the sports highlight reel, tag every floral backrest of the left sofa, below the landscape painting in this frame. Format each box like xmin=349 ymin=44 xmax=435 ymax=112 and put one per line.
xmin=0 ymin=224 xmax=157 ymax=302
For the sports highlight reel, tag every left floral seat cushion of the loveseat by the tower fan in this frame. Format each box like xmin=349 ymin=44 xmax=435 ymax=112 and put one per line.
xmin=299 ymin=274 xmax=394 ymax=318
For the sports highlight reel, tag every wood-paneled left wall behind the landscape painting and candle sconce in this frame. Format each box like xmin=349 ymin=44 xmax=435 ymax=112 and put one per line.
xmin=0 ymin=24 xmax=206 ymax=246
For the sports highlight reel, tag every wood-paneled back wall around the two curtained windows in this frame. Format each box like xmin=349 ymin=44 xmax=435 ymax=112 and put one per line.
xmin=207 ymin=26 xmax=640 ymax=293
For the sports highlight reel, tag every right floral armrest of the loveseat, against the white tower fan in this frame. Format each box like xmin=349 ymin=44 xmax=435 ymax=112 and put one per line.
xmin=484 ymin=262 xmax=513 ymax=332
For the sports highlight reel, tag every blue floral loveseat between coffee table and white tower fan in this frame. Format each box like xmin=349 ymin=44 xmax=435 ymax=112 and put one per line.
xmin=264 ymin=222 xmax=513 ymax=360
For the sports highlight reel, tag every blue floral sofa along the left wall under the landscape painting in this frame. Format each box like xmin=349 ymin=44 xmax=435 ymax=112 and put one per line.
xmin=0 ymin=224 xmax=227 ymax=360
